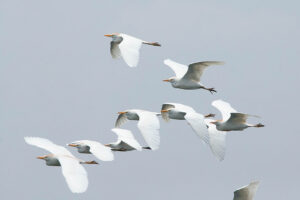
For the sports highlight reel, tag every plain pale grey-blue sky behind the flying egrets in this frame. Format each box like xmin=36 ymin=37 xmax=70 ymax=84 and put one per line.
xmin=0 ymin=0 xmax=300 ymax=200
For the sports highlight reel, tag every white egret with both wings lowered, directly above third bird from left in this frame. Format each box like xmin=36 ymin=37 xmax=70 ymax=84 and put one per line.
xmin=115 ymin=109 xmax=160 ymax=150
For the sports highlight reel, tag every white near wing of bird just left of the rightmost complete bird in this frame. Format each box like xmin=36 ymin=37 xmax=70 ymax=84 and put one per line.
xmin=184 ymin=112 xmax=209 ymax=144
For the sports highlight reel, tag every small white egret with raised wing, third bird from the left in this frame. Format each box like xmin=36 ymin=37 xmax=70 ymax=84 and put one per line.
xmin=105 ymin=128 xmax=150 ymax=151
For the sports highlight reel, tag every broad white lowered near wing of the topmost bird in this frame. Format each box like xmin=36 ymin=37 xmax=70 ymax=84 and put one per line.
xmin=119 ymin=33 xmax=142 ymax=67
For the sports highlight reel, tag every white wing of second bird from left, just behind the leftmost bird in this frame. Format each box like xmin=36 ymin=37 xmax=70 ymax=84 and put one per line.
xmin=77 ymin=140 xmax=114 ymax=161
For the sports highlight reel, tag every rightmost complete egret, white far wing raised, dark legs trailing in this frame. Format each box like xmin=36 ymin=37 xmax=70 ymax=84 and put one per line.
xmin=211 ymin=100 xmax=264 ymax=131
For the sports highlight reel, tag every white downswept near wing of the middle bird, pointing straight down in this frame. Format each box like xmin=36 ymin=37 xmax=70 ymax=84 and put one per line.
xmin=137 ymin=111 xmax=160 ymax=150
